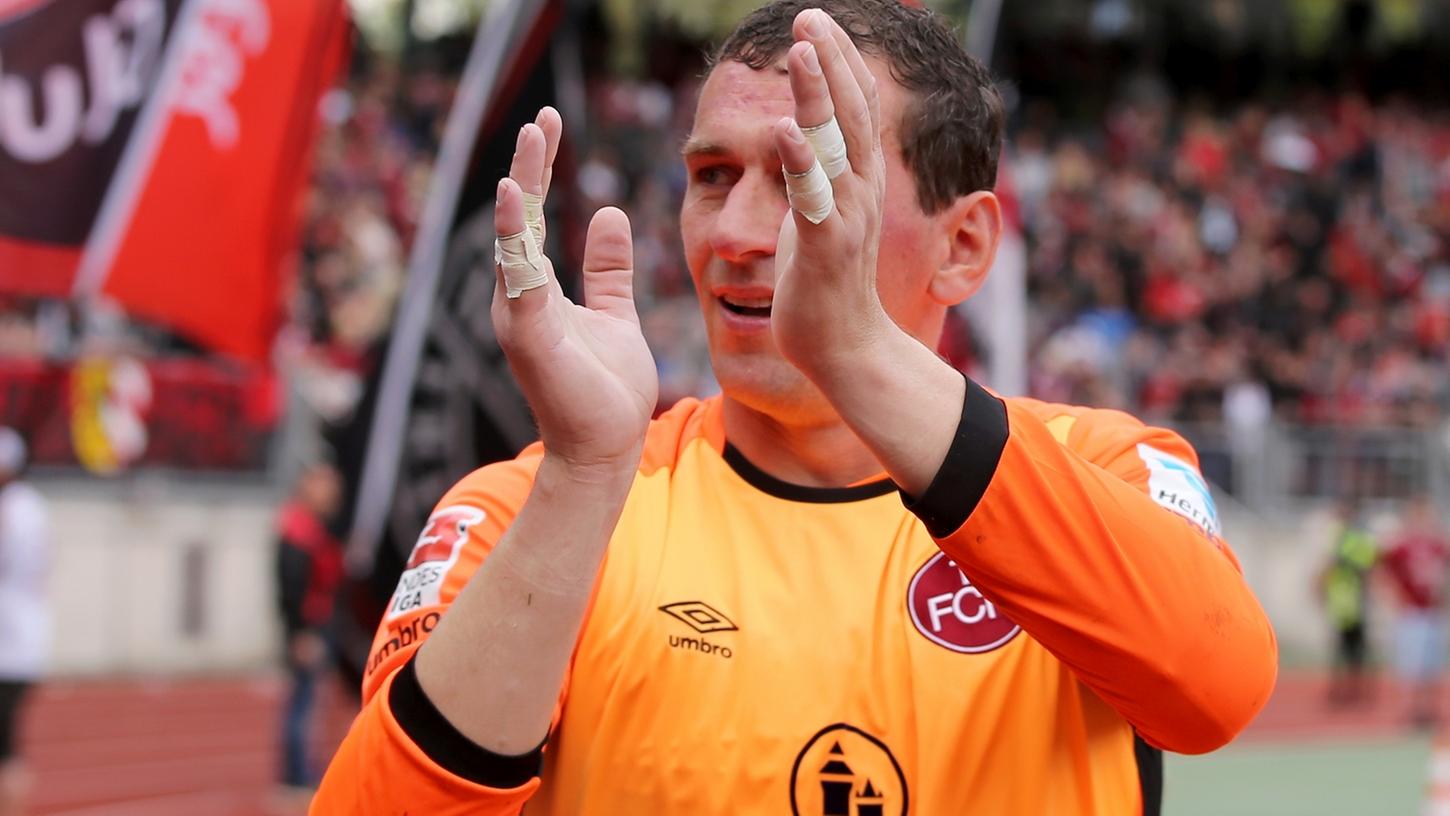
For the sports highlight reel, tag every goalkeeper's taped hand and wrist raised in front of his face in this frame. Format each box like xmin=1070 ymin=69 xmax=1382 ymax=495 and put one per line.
xmin=770 ymin=9 xmax=966 ymax=496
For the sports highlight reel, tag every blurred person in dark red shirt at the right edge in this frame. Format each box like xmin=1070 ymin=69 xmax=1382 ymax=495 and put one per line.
xmin=1383 ymin=496 xmax=1450 ymax=728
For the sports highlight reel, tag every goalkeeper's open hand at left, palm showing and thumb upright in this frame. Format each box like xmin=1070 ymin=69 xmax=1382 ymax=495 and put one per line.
xmin=493 ymin=107 xmax=660 ymax=477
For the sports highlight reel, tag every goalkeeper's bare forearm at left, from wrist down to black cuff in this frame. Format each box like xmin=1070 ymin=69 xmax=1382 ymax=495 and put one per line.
xmin=415 ymin=455 xmax=635 ymax=755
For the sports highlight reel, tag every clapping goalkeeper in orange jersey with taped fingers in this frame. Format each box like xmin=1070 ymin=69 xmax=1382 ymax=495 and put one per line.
xmin=313 ymin=0 xmax=1276 ymax=816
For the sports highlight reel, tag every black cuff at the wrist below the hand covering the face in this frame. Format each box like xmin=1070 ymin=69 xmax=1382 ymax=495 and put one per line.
xmin=902 ymin=378 xmax=1008 ymax=539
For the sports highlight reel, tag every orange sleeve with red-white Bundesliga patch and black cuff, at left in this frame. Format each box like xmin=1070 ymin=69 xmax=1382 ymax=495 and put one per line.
xmin=310 ymin=449 xmax=563 ymax=816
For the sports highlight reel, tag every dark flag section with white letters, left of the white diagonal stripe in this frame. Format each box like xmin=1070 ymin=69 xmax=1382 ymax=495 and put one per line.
xmin=0 ymin=0 xmax=181 ymax=289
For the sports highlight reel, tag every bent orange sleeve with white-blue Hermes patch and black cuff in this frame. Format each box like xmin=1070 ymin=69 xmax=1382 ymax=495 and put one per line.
xmin=908 ymin=383 xmax=1277 ymax=754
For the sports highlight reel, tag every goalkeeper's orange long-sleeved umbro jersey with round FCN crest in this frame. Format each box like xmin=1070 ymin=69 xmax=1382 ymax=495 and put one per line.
xmin=313 ymin=383 xmax=1276 ymax=816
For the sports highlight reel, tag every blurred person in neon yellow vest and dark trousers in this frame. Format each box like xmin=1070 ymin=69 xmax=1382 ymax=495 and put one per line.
xmin=1320 ymin=500 xmax=1378 ymax=706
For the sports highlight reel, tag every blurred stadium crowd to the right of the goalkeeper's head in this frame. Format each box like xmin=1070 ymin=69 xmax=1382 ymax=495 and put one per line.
xmin=1009 ymin=87 xmax=1450 ymax=426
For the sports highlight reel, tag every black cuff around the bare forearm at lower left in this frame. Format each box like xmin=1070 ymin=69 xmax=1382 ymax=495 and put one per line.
xmin=387 ymin=655 xmax=544 ymax=790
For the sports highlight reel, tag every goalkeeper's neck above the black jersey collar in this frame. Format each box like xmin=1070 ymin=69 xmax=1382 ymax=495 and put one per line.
xmin=722 ymin=396 xmax=882 ymax=487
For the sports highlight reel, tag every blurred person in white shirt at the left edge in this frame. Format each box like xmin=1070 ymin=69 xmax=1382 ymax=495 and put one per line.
xmin=0 ymin=428 xmax=49 ymax=816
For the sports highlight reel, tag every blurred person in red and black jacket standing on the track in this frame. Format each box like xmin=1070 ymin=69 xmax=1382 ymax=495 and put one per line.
xmin=277 ymin=464 xmax=342 ymax=788
